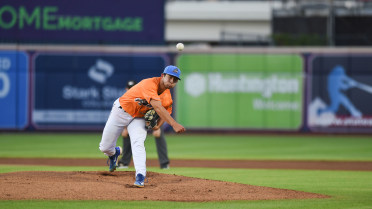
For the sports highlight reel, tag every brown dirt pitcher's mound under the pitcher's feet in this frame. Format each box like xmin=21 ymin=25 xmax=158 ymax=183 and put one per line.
xmin=0 ymin=171 xmax=327 ymax=202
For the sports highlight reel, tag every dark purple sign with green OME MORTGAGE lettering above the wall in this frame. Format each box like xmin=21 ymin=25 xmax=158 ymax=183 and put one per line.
xmin=0 ymin=0 xmax=164 ymax=44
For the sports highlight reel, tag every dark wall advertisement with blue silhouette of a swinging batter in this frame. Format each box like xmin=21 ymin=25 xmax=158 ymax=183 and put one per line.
xmin=307 ymin=54 xmax=372 ymax=132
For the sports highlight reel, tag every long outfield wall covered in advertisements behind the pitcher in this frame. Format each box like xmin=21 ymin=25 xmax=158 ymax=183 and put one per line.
xmin=0 ymin=45 xmax=372 ymax=133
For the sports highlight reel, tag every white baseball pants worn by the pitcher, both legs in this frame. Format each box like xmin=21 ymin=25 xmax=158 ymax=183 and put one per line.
xmin=99 ymin=99 xmax=147 ymax=176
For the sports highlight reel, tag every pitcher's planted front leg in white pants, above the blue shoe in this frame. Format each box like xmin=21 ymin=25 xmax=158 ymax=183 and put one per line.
xmin=128 ymin=118 xmax=147 ymax=176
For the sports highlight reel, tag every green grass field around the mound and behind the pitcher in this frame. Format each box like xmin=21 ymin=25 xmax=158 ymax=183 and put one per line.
xmin=0 ymin=133 xmax=372 ymax=209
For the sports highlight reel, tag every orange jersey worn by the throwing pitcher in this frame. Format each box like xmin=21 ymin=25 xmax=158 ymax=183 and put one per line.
xmin=119 ymin=77 xmax=173 ymax=118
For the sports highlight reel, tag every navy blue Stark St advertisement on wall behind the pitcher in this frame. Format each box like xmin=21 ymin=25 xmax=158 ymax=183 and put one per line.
xmin=32 ymin=53 xmax=167 ymax=129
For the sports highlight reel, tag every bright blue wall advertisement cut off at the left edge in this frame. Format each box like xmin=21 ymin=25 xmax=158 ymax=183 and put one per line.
xmin=0 ymin=51 xmax=28 ymax=129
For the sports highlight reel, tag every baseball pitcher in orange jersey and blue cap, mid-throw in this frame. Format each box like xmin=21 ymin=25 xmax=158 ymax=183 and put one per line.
xmin=99 ymin=65 xmax=186 ymax=187
